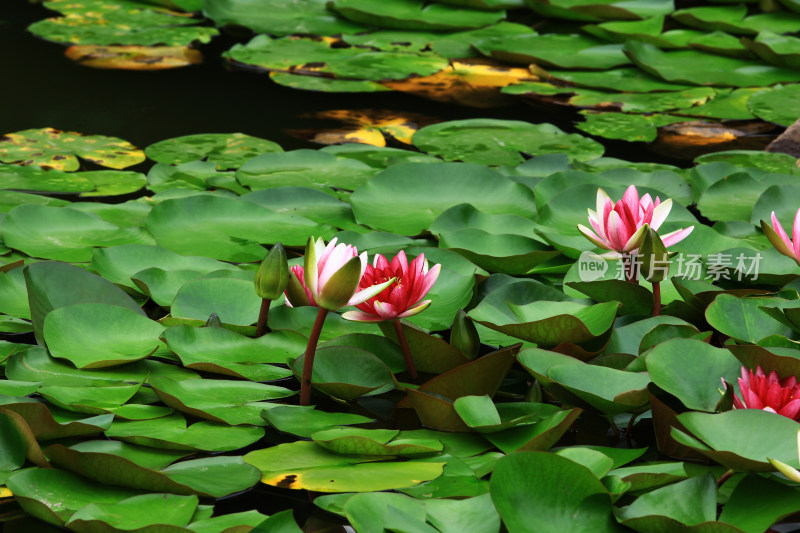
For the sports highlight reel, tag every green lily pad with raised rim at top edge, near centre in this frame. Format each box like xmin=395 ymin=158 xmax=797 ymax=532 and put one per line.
xmin=329 ymin=0 xmax=505 ymax=31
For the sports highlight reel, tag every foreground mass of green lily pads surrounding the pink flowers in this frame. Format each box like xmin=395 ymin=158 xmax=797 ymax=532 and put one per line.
xmin=0 ymin=121 xmax=800 ymax=533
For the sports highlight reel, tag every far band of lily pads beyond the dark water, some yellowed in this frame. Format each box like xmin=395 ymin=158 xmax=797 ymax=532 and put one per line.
xmin=23 ymin=0 xmax=800 ymax=150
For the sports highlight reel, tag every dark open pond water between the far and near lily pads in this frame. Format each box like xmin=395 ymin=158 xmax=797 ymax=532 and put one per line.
xmin=0 ymin=0 xmax=685 ymax=165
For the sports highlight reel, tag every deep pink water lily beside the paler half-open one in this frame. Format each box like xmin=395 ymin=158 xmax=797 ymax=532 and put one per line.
xmin=342 ymin=250 xmax=442 ymax=322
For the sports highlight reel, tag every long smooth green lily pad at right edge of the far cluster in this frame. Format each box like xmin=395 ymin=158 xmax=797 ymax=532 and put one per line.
xmin=625 ymin=41 xmax=800 ymax=87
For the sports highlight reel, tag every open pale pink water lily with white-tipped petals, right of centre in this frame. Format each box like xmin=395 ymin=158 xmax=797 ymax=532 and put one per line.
xmin=578 ymin=185 xmax=694 ymax=253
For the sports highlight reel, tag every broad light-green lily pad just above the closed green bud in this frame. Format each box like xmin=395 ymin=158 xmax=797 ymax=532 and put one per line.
xmin=147 ymin=196 xmax=334 ymax=262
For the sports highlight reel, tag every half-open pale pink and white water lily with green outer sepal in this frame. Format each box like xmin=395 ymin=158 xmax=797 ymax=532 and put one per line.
xmin=286 ymin=237 xmax=393 ymax=311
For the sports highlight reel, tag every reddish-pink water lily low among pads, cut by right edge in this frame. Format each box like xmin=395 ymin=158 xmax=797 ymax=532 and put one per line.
xmin=723 ymin=365 xmax=800 ymax=420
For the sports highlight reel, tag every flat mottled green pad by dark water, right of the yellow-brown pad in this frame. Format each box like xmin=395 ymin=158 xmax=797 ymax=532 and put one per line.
xmin=144 ymin=131 xmax=283 ymax=170
